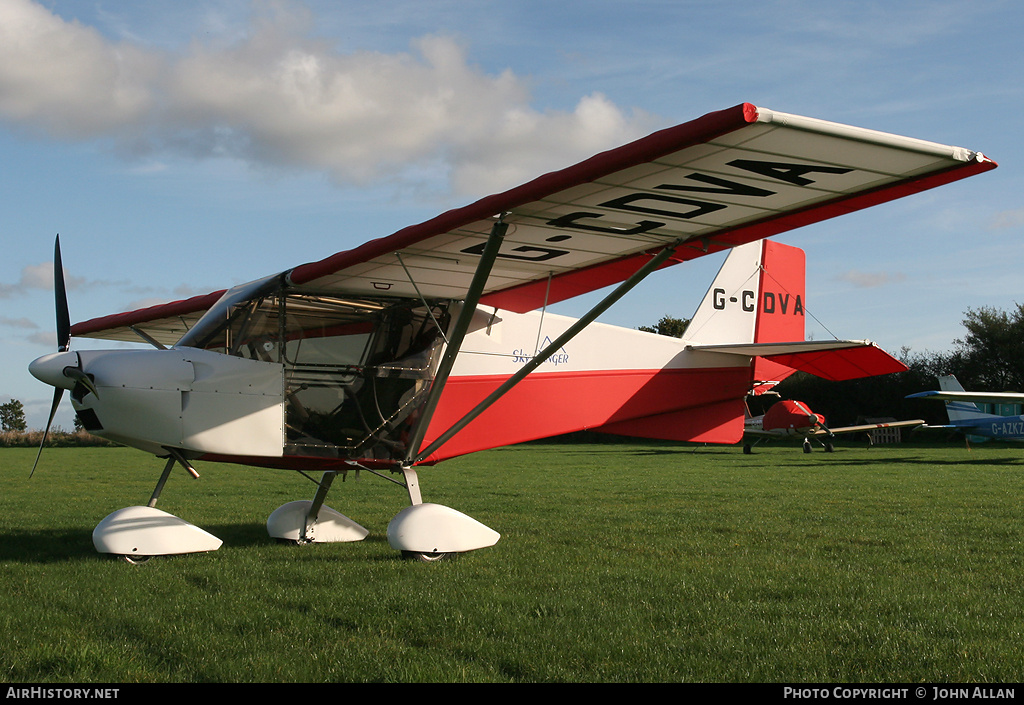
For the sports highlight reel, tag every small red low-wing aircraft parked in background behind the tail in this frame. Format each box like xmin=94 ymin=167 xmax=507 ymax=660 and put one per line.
xmin=743 ymin=393 xmax=925 ymax=453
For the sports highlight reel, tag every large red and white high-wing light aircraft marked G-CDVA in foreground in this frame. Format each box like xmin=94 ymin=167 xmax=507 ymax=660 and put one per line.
xmin=30 ymin=103 xmax=996 ymax=561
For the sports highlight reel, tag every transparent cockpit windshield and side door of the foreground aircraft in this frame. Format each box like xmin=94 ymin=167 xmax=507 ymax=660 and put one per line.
xmin=177 ymin=277 xmax=450 ymax=458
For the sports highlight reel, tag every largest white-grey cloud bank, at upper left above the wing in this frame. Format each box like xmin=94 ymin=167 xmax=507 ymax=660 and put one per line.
xmin=0 ymin=0 xmax=653 ymax=195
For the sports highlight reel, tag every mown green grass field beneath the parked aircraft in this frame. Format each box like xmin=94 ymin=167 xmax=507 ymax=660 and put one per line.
xmin=0 ymin=444 xmax=1024 ymax=683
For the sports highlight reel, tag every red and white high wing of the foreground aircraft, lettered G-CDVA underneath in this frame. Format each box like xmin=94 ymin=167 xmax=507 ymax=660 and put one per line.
xmin=72 ymin=103 xmax=996 ymax=344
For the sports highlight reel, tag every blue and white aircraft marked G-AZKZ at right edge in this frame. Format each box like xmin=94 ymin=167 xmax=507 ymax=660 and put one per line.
xmin=907 ymin=375 xmax=1024 ymax=441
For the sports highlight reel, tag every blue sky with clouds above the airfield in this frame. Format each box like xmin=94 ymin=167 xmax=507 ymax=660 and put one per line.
xmin=0 ymin=0 xmax=1024 ymax=428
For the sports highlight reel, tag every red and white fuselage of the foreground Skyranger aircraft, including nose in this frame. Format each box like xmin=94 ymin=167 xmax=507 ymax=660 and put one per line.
xmin=31 ymin=289 xmax=751 ymax=468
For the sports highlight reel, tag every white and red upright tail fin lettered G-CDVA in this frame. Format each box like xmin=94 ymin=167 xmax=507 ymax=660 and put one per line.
xmin=683 ymin=240 xmax=806 ymax=383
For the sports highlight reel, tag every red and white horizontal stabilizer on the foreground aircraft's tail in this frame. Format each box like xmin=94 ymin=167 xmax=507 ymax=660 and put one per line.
xmin=689 ymin=340 xmax=907 ymax=381
